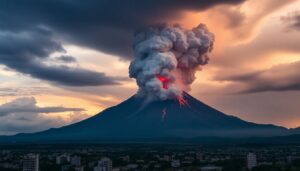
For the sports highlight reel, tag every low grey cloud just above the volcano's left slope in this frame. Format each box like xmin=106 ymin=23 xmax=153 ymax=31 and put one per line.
xmin=0 ymin=97 xmax=84 ymax=117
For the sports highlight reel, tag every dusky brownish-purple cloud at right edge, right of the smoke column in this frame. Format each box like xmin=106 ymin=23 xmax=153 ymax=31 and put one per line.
xmin=215 ymin=62 xmax=300 ymax=93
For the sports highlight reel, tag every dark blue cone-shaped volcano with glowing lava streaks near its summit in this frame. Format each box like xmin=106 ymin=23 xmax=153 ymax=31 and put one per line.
xmin=0 ymin=93 xmax=288 ymax=142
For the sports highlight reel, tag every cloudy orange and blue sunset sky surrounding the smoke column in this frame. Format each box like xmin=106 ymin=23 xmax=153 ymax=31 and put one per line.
xmin=0 ymin=0 xmax=300 ymax=135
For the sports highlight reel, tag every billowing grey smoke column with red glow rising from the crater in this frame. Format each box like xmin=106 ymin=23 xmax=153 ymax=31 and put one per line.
xmin=129 ymin=24 xmax=214 ymax=100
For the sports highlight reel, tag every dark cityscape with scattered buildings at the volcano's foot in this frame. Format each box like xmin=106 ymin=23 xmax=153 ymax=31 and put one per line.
xmin=0 ymin=144 xmax=300 ymax=171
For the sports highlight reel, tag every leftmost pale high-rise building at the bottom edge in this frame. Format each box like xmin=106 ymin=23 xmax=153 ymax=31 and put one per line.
xmin=23 ymin=154 xmax=39 ymax=171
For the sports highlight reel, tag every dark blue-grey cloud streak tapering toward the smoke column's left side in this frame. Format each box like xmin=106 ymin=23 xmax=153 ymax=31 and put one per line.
xmin=0 ymin=27 xmax=118 ymax=86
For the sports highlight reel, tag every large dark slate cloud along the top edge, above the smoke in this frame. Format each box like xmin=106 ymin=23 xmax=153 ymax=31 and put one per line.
xmin=0 ymin=0 xmax=244 ymax=58
